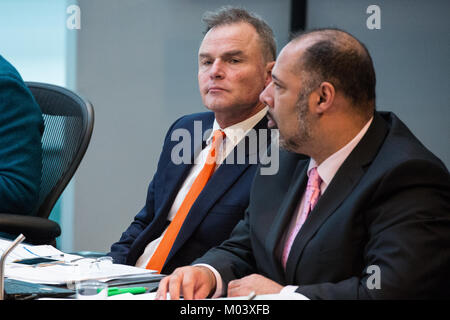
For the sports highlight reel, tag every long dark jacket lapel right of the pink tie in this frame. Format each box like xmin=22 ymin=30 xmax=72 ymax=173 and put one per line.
xmin=286 ymin=113 xmax=388 ymax=283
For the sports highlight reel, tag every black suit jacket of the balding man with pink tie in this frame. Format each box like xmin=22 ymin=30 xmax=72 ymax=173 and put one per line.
xmin=194 ymin=112 xmax=450 ymax=299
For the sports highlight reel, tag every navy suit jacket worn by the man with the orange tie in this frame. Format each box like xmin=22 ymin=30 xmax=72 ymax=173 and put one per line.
xmin=108 ymin=112 xmax=270 ymax=274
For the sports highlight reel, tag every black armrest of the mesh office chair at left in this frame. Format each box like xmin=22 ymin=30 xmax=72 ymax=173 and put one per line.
xmin=0 ymin=213 xmax=61 ymax=242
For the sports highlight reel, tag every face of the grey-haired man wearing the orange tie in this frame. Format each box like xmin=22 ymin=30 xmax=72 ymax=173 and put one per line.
xmin=198 ymin=23 xmax=270 ymax=119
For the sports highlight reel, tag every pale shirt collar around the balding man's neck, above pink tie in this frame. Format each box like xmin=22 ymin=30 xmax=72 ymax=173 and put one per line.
xmin=308 ymin=117 xmax=373 ymax=193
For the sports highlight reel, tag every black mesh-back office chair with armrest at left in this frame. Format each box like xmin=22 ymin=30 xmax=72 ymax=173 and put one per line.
xmin=0 ymin=82 xmax=94 ymax=246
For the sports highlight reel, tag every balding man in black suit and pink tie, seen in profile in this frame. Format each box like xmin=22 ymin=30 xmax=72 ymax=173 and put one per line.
xmin=158 ymin=29 xmax=450 ymax=299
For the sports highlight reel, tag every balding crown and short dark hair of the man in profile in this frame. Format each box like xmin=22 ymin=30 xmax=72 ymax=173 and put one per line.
xmin=292 ymin=29 xmax=376 ymax=116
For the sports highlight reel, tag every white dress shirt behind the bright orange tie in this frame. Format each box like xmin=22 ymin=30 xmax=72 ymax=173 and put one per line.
xmin=136 ymin=107 xmax=267 ymax=268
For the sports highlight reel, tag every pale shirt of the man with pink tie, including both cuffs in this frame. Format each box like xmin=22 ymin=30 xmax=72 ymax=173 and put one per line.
xmin=202 ymin=117 xmax=373 ymax=298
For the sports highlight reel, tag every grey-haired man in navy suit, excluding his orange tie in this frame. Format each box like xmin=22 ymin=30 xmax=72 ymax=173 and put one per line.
xmin=109 ymin=8 xmax=276 ymax=273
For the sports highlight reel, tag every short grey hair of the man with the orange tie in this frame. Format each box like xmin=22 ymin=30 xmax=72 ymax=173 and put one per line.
xmin=202 ymin=6 xmax=277 ymax=61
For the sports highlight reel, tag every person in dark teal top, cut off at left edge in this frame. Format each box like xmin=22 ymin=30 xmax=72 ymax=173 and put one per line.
xmin=0 ymin=56 xmax=44 ymax=215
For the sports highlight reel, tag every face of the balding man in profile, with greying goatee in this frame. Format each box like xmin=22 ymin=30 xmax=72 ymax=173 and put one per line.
xmin=260 ymin=41 xmax=313 ymax=153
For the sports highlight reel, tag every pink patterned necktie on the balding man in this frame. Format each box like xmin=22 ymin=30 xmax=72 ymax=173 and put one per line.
xmin=281 ymin=167 xmax=322 ymax=269
